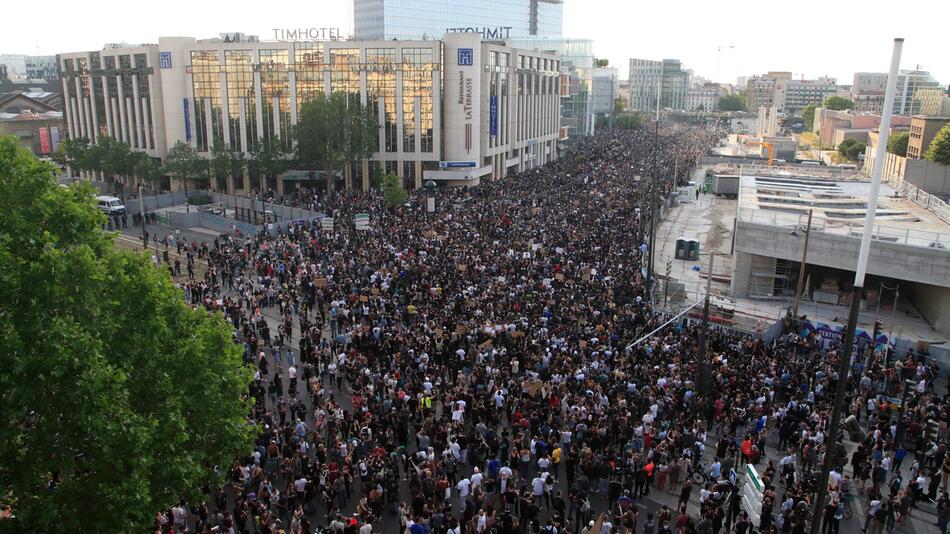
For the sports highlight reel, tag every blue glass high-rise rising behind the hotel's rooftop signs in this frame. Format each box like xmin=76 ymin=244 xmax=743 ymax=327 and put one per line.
xmin=353 ymin=0 xmax=564 ymax=41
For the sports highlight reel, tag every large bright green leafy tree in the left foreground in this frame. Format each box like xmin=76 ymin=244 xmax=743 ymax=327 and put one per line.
xmin=0 ymin=137 xmax=257 ymax=532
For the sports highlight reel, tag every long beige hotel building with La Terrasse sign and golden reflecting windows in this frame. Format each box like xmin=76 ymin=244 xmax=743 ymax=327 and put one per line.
xmin=59 ymin=33 xmax=560 ymax=193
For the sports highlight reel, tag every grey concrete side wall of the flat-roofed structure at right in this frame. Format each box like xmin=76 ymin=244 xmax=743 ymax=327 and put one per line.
xmin=733 ymin=221 xmax=950 ymax=287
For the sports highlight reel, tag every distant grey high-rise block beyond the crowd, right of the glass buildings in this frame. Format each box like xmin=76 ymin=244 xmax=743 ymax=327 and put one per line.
xmin=630 ymin=59 xmax=689 ymax=111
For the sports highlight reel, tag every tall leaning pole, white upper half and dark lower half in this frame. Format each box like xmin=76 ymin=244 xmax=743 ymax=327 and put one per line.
xmin=811 ymin=38 xmax=904 ymax=534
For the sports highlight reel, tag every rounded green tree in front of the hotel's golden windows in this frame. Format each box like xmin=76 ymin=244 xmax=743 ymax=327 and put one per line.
xmin=295 ymin=92 xmax=379 ymax=191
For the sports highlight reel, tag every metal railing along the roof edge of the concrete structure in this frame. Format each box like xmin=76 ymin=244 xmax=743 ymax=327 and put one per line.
xmin=738 ymin=208 xmax=950 ymax=253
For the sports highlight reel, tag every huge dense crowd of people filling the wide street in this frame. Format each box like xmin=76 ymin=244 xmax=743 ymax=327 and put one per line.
xmin=156 ymin=126 xmax=950 ymax=534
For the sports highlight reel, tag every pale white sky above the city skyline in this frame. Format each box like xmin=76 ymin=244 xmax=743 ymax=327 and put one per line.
xmin=0 ymin=0 xmax=950 ymax=85
